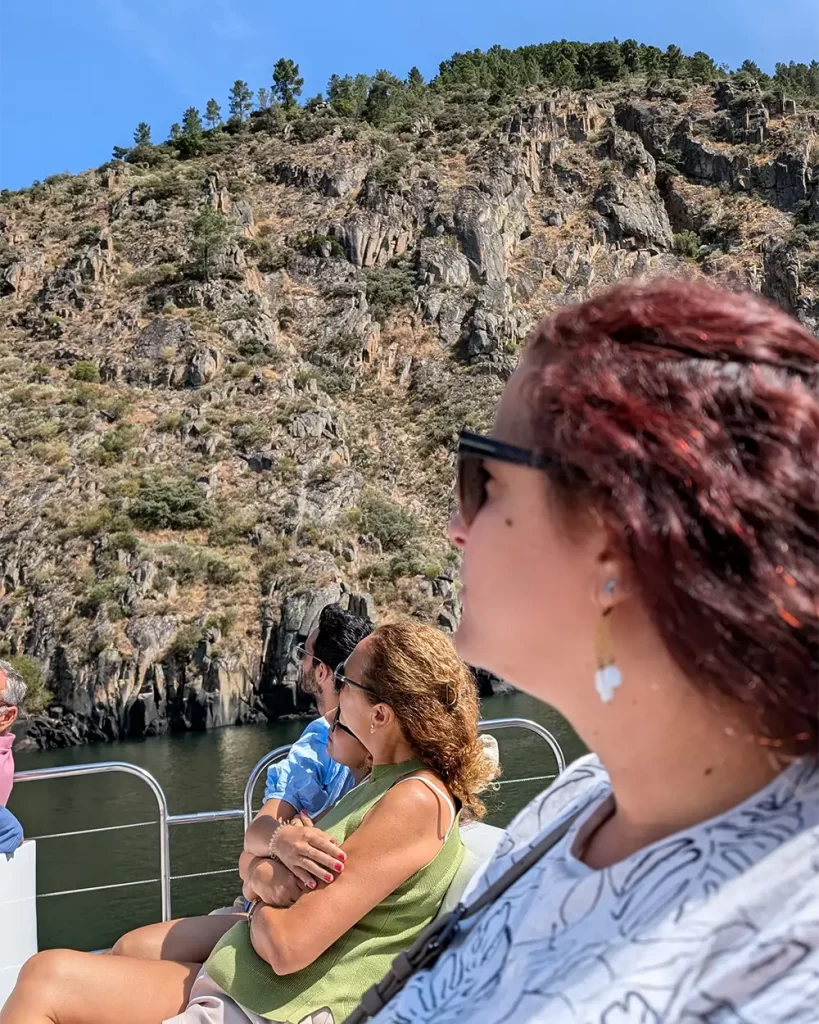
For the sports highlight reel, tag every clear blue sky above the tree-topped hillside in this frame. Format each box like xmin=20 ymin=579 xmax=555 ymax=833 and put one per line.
xmin=0 ymin=0 xmax=819 ymax=188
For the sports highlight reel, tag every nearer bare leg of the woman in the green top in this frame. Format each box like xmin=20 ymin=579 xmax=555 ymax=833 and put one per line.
xmin=0 ymin=949 xmax=201 ymax=1024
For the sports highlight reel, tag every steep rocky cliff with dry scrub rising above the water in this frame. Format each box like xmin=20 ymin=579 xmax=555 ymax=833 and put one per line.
xmin=0 ymin=58 xmax=819 ymax=744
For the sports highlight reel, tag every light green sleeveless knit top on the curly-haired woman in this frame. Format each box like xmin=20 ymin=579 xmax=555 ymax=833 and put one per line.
xmin=205 ymin=761 xmax=464 ymax=1024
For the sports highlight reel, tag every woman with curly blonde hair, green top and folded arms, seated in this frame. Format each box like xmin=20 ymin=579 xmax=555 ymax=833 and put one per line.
xmin=0 ymin=623 xmax=495 ymax=1024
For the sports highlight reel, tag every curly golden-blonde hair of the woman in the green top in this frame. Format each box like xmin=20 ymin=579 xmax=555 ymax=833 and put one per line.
xmin=362 ymin=622 xmax=499 ymax=818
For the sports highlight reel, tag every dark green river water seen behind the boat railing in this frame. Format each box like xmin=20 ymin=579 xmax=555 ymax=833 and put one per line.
xmin=9 ymin=694 xmax=583 ymax=949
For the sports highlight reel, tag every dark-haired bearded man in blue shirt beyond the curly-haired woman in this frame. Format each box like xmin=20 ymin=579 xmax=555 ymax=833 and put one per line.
xmin=245 ymin=604 xmax=373 ymax=857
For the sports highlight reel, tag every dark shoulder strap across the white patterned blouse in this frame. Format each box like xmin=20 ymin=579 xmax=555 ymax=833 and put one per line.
xmin=345 ymin=811 xmax=581 ymax=1024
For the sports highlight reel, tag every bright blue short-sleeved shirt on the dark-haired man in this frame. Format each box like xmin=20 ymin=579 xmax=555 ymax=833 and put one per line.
xmin=264 ymin=718 xmax=355 ymax=818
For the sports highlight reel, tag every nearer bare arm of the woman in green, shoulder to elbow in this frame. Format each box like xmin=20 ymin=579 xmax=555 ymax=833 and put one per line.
xmin=251 ymin=782 xmax=450 ymax=975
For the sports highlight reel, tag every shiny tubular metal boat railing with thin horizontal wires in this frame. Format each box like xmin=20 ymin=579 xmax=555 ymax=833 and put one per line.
xmin=14 ymin=718 xmax=566 ymax=921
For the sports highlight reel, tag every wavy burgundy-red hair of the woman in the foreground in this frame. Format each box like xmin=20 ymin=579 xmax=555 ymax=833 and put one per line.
xmin=526 ymin=281 xmax=819 ymax=753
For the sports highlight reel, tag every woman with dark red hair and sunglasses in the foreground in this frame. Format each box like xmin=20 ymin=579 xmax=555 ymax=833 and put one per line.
xmin=356 ymin=281 xmax=819 ymax=1024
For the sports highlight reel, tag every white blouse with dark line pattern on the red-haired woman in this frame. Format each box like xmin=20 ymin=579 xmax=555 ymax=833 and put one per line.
xmin=376 ymin=756 xmax=819 ymax=1024
